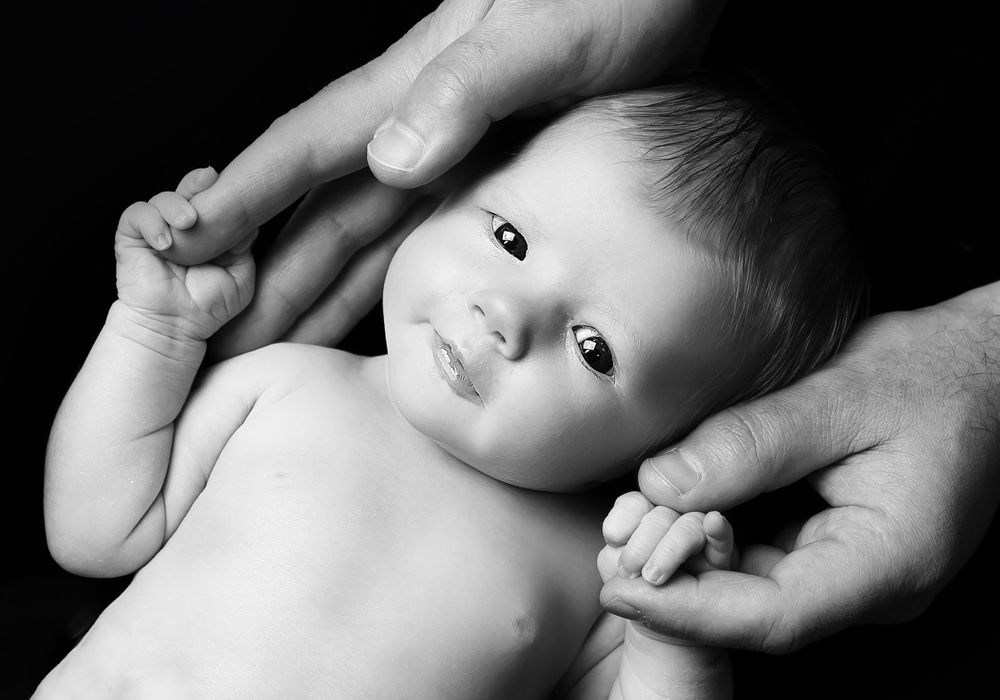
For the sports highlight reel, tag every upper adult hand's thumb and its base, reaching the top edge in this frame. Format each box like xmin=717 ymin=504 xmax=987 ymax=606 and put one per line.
xmin=368 ymin=0 xmax=721 ymax=187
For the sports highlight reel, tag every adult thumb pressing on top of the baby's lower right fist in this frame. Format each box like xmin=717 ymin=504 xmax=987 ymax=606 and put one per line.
xmin=639 ymin=368 xmax=869 ymax=511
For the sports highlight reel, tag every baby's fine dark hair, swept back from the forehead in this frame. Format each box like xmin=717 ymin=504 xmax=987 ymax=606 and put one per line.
xmin=570 ymin=73 xmax=865 ymax=415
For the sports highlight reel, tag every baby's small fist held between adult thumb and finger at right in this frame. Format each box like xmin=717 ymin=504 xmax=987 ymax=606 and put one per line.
xmin=598 ymin=491 xmax=736 ymax=586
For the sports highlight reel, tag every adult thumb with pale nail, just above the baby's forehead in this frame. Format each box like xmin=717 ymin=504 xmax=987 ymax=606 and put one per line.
xmin=368 ymin=12 xmax=579 ymax=187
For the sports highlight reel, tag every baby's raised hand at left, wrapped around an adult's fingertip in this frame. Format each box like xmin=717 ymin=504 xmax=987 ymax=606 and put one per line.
xmin=115 ymin=168 xmax=254 ymax=340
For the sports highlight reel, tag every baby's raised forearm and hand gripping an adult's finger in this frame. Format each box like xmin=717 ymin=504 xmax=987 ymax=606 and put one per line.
xmin=44 ymin=169 xmax=253 ymax=576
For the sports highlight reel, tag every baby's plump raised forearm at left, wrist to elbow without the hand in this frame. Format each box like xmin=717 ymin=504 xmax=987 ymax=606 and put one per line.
xmin=45 ymin=302 xmax=205 ymax=576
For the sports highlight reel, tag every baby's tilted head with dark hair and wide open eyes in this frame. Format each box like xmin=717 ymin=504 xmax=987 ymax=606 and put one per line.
xmin=384 ymin=69 xmax=861 ymax=491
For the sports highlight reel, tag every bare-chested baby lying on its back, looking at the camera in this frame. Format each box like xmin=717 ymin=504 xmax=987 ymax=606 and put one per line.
xmin=37 ymin=77 xmax=859 ymax=698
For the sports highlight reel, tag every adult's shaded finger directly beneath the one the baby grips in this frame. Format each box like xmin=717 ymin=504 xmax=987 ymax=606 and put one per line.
xmin=211 ymin=173 xmax=415 ymax=357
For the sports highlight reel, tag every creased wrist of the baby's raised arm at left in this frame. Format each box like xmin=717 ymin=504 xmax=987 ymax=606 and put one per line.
xmin=105 ymin=300 xmax=205 ymax=366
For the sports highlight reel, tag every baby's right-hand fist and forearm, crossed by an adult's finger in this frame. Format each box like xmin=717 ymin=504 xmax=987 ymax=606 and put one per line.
xmin=584 ymin=492 xmax=736 ymax=700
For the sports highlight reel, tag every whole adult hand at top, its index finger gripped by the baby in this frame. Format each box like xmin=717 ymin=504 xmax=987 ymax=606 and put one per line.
xmin=158 ymin=0 xmax=723 ymax=354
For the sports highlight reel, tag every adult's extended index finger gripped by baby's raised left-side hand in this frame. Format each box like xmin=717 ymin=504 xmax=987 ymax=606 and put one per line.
xmin=158 ymin=0 xmax=489 ymax=266
